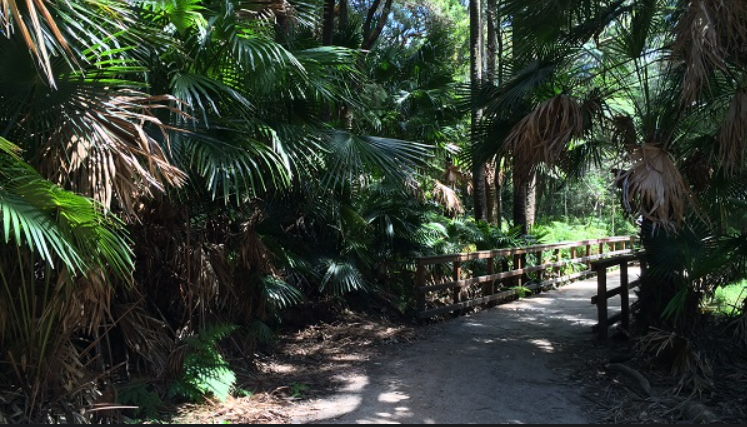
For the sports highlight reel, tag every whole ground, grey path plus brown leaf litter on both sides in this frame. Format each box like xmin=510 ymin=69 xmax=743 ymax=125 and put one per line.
xmin=169 ymin=270 xmax=747 ymax=424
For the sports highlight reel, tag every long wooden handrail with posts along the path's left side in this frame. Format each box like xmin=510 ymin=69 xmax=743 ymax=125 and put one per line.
xmin=415 ymin=236 xmax=636 ymax=318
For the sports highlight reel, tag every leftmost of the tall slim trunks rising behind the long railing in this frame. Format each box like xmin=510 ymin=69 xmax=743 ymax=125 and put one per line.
xmin=470 ymin=0 xmax=488 ymax=221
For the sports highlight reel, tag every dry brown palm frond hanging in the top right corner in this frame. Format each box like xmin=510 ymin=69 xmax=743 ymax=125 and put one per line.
xmin=674 ymin=0 xmax=747 ymax=103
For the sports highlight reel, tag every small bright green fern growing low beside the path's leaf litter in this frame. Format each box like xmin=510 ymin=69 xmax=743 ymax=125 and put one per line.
xmin=169 ymin=324 xmax=237 ymax=402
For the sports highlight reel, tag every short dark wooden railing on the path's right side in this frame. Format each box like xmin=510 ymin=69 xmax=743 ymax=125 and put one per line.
xmin=591 ymin=252 xmax=646 ymax=340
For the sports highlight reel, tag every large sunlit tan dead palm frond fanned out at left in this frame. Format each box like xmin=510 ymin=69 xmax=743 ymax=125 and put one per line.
xmin=40 ymin=90 xmax=186 ymax=214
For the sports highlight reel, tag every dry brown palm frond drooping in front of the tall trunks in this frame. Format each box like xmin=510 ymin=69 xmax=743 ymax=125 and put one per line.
xmin=505 ymin=95 xmax=584 ymax=181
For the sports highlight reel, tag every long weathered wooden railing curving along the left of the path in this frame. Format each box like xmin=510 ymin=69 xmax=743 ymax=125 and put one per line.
xmin=416 ymin=236 xmax=636 ymax=319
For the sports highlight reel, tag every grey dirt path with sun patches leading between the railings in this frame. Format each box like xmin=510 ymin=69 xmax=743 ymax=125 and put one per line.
xmin=290 ymin=271 xmax=637 ymax=424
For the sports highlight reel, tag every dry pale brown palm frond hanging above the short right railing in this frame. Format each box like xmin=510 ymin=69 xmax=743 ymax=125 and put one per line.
xmin=620 ymin=144 xmax=694 ymax=236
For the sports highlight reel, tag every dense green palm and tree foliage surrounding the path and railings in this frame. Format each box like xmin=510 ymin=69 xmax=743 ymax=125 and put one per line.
xmin=0 ymin=0 xmax=747 ymax=422
